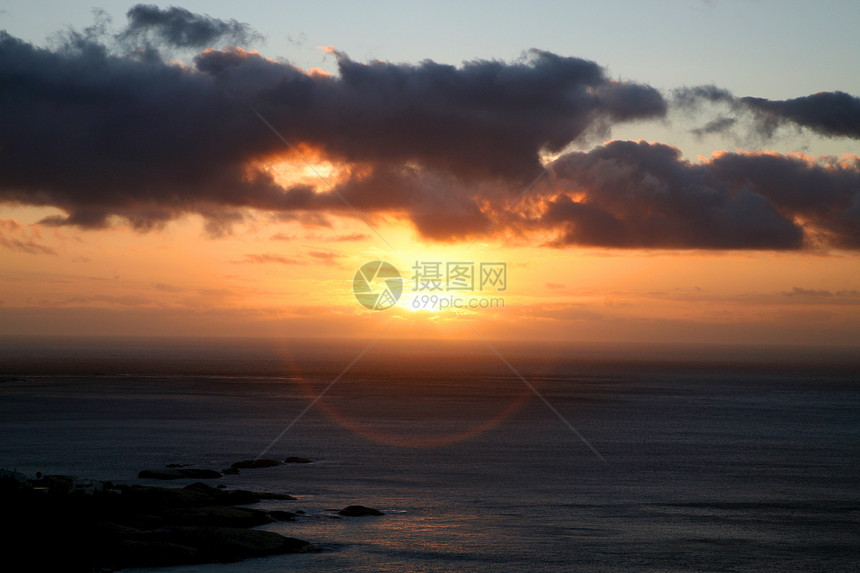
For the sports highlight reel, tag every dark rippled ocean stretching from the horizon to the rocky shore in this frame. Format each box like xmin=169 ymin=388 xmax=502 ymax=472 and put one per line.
xmin=0 ymin=337 xmax=860 ymax=573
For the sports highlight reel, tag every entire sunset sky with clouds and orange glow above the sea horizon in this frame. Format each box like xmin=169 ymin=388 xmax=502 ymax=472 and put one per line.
xmin=0 ymin=0 xmax=860 ymax=345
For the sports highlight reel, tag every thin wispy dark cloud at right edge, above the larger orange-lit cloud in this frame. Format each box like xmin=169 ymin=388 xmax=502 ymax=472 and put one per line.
xmin=672 ymin=86 xmax=860 ymax=139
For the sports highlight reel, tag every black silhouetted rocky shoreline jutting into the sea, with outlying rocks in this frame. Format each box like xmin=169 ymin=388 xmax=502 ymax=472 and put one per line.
xmin=0 ymin=458 xmax=382 ymax=572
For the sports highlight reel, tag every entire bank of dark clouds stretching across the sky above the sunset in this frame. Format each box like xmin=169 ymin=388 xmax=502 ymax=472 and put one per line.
xmin=0 ymin=5 xmax=860 ymax=249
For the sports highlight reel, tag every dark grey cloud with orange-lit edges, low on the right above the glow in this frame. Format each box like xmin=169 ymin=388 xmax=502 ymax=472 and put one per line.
xmin=536 ymin=141 xmax=860 ymax=250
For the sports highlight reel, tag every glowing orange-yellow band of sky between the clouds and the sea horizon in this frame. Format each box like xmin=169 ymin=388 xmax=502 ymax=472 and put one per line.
xmin=0 ymin=200 xmax=860 ymax=343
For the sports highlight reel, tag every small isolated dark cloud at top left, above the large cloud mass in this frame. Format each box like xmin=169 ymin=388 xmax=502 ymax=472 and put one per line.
xmin=118 ymin=4 xmax=262 ymax=48
